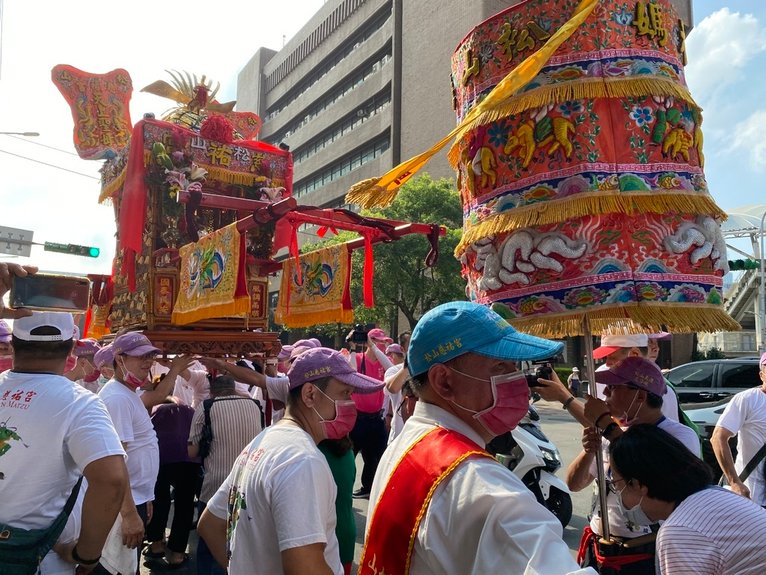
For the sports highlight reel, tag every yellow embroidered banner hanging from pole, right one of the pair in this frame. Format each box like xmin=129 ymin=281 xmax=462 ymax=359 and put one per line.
xmin=274 ymin=244 xmax=354 ymax=327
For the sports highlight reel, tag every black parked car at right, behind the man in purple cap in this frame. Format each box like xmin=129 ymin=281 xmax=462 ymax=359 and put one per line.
xmin=665 ymin=357 xmax=761 ymax=404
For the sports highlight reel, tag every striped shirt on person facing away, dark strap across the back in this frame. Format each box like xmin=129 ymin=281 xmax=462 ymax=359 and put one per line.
xmin=189 ymin=395 xmax=261 ymax=502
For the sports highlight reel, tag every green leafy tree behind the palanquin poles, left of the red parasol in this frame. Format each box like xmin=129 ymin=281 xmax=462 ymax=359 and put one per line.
xmin=280 ymin=174 xmax=465 ymax=341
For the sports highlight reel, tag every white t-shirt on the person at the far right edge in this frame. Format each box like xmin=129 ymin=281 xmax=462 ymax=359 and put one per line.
xmin=717 ymin=387 xmax=766 ymax=505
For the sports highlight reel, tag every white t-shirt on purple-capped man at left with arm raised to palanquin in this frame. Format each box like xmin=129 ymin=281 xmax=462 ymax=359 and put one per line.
xmin=99 ymin=379 xmax=160 ymax=505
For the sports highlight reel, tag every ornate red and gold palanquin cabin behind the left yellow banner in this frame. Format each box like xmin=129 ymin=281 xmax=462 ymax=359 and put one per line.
xmin=102 ymin=120 xmax=292 ymax=336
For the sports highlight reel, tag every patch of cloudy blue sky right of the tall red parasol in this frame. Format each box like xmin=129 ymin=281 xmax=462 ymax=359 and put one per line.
xmin=686 ymin=0 xmax=766 ymax=211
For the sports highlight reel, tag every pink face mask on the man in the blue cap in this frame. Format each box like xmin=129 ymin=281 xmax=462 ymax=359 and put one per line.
xmin=450 ymin=368 xmax=529 ymax=437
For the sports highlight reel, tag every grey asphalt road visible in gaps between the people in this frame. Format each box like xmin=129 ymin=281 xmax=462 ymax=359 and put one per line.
xmin=141 ymin=401 xmax=591 ymax=575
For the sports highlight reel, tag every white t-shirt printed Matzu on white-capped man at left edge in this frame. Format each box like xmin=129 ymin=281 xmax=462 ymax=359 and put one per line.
xmin=0 ymin=371 xmax=125 ymax=575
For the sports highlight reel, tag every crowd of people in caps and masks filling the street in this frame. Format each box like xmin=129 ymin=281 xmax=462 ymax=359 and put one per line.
xmin=0 ymin=263 xmax=766 ymax=575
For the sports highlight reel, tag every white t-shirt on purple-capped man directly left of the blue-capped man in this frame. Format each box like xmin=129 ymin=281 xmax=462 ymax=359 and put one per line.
xmin=207 ymin=423 xmax=343 ymax=575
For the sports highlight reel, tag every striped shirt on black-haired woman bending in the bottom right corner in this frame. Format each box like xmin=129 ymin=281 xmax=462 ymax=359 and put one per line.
xmin=657 ymin=488 xmax=766 ymax=575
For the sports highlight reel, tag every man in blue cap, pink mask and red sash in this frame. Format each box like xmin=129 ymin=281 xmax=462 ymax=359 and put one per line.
xmin=359 ymin=302 xmax=595 ymax=575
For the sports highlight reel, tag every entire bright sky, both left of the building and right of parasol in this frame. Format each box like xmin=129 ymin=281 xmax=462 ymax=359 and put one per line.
xmin=0 ymin=0 xmax=766 ymax=280
